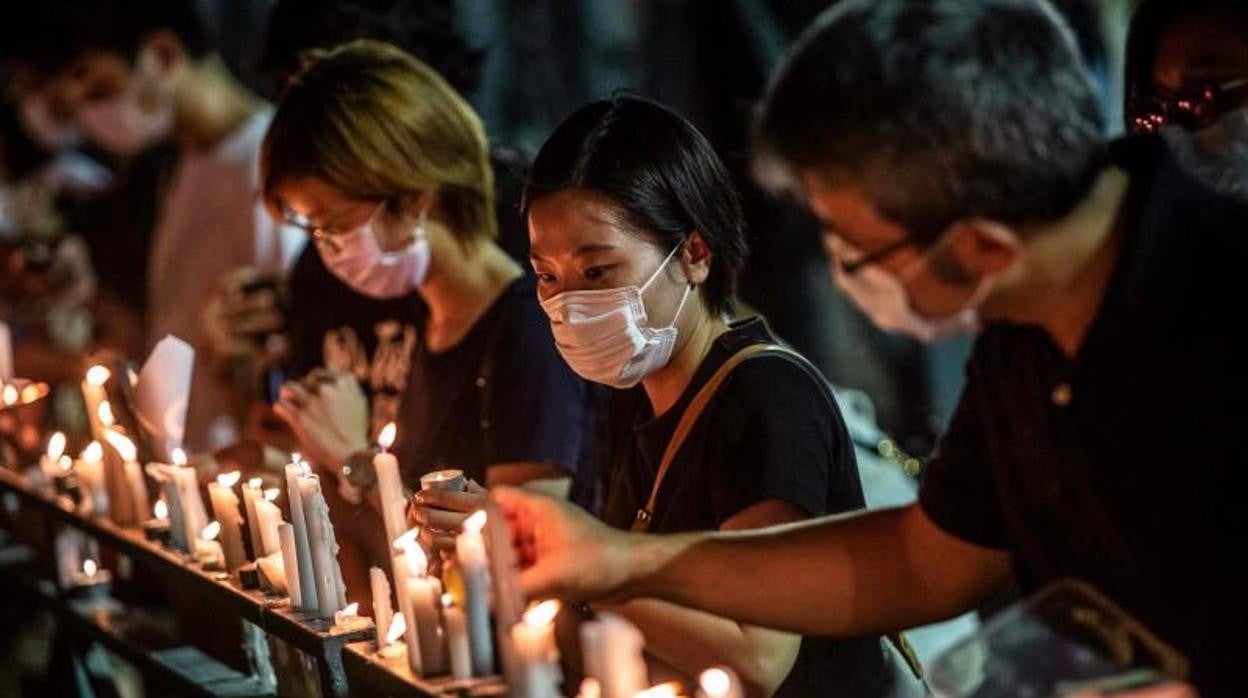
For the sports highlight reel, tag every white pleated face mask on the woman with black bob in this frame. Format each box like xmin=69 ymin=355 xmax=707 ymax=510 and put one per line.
xmin=542 ymin=245 xmax=693 ymax=388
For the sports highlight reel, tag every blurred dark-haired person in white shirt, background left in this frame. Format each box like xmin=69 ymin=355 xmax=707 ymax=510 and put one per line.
xmin=6 ymin=0 xmax=303 ymax=451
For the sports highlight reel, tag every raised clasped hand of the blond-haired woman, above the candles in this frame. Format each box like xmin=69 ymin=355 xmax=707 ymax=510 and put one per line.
xmin=273 ymin=368 xmax=368 ymax=473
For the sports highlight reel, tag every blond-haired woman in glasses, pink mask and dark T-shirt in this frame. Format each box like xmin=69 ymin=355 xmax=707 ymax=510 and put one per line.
xmin=261 ymin=40 xmax=589 ymax=579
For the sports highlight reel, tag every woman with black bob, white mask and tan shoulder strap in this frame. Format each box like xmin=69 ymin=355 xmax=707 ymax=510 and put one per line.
xmin=523 ymin=96 xmax=891 ymax=696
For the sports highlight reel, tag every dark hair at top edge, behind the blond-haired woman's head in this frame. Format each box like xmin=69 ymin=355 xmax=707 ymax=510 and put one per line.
xmin=258 ymin=0 xmax=482 ymax=95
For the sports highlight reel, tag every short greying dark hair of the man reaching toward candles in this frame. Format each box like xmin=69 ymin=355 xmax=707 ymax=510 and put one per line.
xmin=755 ymin=0 xmax=1106 ymax=237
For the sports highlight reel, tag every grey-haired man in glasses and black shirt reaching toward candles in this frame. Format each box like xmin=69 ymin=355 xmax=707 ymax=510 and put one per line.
xmin=495 ymin=0 xmax=1248 ymax=696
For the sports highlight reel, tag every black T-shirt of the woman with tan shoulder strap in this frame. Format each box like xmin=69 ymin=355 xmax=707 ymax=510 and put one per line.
xmin=603 ymin=318 xmax=892 ymax=696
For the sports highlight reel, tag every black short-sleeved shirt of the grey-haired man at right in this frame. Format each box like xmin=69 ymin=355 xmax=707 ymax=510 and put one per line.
xmin=920 ymin=139 xmax=1248 ymax=696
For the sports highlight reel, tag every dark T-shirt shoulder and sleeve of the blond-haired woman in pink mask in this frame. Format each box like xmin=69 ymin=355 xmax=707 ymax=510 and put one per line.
xmin=396 ymin=276 xmax=589 ymax=488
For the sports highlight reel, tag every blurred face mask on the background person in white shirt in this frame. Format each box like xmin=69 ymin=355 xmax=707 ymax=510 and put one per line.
xmin=77 ymin=51 xmax=173 ymax=157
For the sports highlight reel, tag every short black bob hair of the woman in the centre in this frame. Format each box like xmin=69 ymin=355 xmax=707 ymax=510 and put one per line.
xmin=520 ymin=96 xmax=746 ymax=313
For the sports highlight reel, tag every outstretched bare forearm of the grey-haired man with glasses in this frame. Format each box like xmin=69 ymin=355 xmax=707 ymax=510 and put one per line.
xmin=622 ymin=506 xmax=1008 ymax=636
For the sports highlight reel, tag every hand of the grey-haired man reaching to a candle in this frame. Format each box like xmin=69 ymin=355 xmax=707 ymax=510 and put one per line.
xmin=490 ymin=487 xmax=635 ymax=601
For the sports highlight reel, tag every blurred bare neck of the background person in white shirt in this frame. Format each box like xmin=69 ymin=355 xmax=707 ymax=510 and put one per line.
xmin=175 ymin=54 xmax=265 ymax=152
